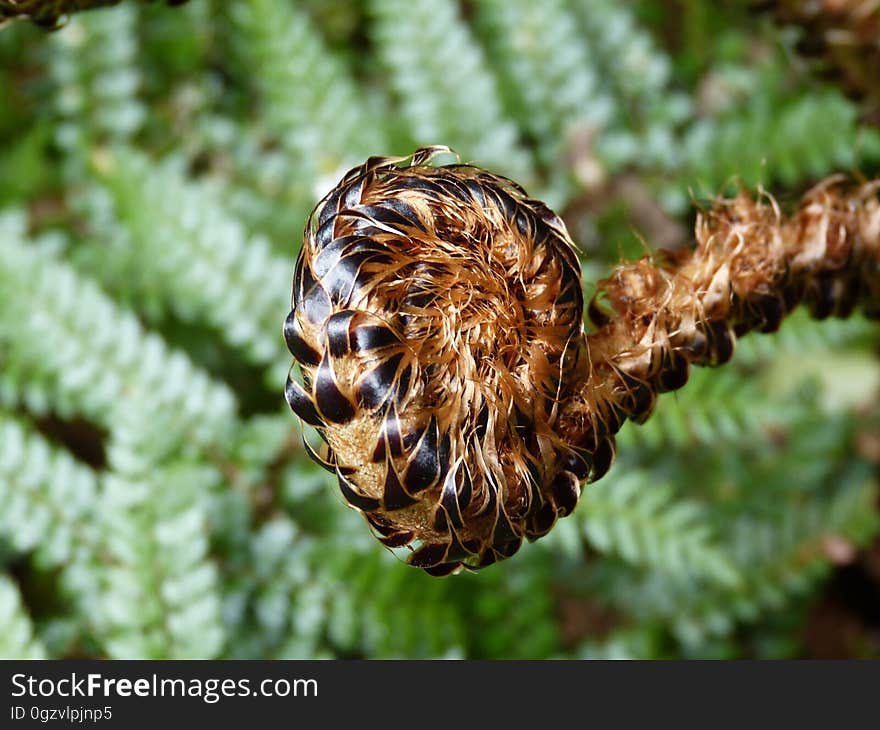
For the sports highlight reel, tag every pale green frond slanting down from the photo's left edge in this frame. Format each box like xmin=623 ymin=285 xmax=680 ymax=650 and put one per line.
xmin=0 ymin=208 xmax=236 ymax=443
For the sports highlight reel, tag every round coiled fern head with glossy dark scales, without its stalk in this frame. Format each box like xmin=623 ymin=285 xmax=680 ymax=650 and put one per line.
xmin=285 ymin=147 xmax=600 ymax=574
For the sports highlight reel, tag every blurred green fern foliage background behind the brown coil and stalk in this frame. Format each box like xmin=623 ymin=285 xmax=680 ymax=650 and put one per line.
xmin=0 ymin=0 xmax=880 ymax=658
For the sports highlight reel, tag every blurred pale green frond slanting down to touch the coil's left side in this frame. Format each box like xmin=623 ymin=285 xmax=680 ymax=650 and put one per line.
xmin=84 ymin=148 xmax=292 ymax=384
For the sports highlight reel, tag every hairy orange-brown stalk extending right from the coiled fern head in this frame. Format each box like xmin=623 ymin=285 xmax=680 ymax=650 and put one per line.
xmin=559 ymin=177 xmax=880 ymax=466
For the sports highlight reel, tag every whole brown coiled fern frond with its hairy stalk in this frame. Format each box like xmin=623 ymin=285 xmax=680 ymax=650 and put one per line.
xmin=284 ymin=147 xmax=880 ymax=575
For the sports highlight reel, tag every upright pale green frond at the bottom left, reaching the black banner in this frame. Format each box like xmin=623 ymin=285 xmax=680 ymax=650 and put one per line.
xmin=97 ymin=462 xmax=225 ymax=659
